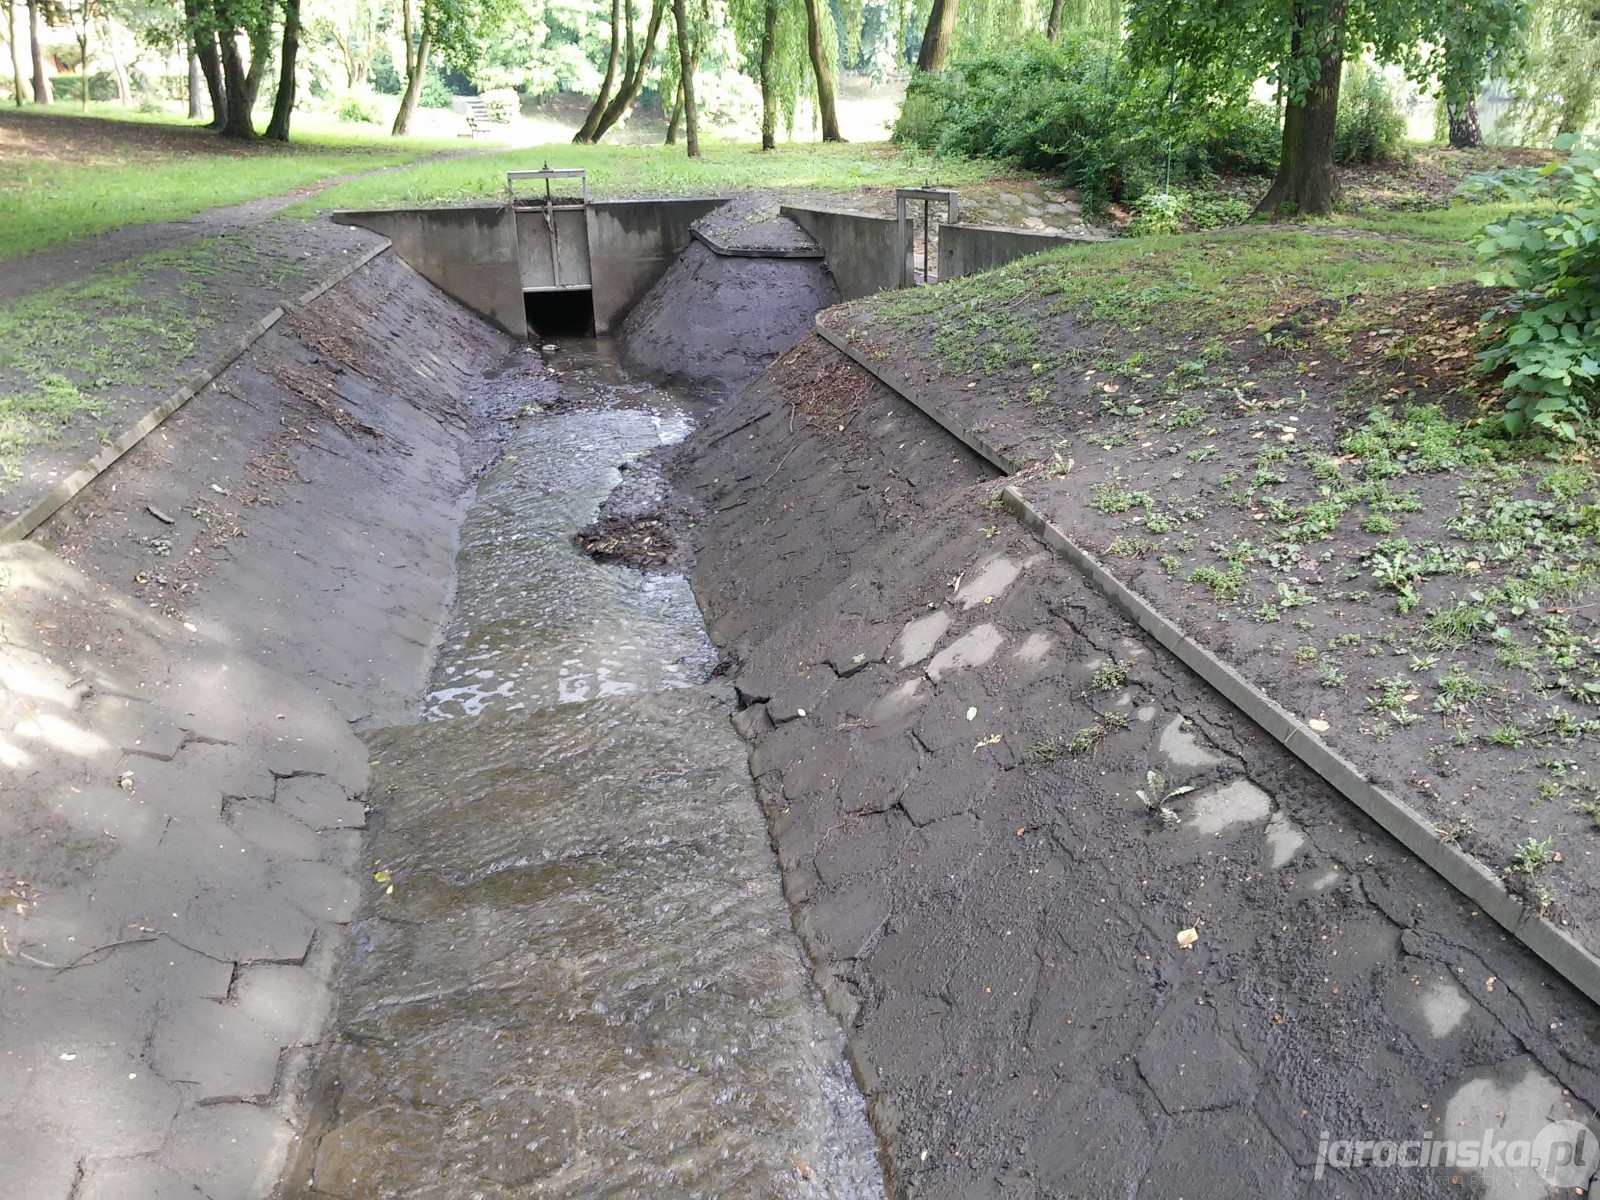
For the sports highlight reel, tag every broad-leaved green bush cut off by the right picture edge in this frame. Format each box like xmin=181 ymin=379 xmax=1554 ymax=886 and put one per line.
xmin=1456 ymin=136 xmax=1600 ymax=438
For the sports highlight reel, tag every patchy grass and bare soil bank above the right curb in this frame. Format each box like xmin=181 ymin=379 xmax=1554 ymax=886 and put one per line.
xmin=830 ymin=178 xmax=1600 ymax=939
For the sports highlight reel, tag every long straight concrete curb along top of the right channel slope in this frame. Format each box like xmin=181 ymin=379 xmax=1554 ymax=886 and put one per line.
xmin=816 ymin=318 xmax=1600 ymax=1003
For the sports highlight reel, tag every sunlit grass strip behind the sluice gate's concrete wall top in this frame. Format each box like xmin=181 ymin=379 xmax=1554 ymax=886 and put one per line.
xmin=298 ymin=142 xmax=1016 ymax=216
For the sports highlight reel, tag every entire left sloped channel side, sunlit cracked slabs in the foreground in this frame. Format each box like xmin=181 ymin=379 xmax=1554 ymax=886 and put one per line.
xmin=0 ymin=256 xmax=515 ymax=1200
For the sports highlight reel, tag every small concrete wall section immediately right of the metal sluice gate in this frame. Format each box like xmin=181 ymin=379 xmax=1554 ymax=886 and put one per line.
xmin=589 ymin=197 xmax=726 ymax=333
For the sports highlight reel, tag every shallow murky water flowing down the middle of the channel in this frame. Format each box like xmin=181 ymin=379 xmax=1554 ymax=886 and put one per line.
xmin=310 ymin=347 xmax=882 ymax=1198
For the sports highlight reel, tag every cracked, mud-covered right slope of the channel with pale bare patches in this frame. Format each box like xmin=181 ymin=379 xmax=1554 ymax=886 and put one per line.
xmin=677 ymin=334 xmax=1600 ymax=1200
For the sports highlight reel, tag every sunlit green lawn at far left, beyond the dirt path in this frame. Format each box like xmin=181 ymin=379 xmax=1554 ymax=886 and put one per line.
xmin=0 ymin=114 xmax=461 ymax=262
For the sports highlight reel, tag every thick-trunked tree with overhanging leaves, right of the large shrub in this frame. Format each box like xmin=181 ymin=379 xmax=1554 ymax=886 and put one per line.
xmin=1128 ymin=0 xmax=1512 ymax=214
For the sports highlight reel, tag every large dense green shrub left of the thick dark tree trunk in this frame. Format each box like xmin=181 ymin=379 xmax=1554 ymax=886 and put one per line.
xmin=894 ymin=37 xmax=1278 ymax=208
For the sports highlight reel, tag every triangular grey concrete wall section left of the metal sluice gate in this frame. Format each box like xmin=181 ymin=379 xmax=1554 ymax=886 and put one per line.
xmin=333 ymin=205 xmax=528 ymax=338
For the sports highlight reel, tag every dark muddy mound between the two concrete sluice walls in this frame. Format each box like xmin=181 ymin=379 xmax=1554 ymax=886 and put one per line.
xmin=618 ymin=242 xmax=838 ymax=395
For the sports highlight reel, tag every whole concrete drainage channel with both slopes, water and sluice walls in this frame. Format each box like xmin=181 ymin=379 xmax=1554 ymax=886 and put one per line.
xmin=0 ymin=184 xmax=1600 ymax=1200
